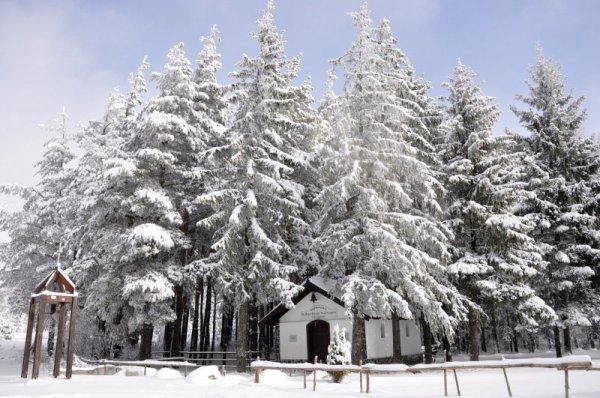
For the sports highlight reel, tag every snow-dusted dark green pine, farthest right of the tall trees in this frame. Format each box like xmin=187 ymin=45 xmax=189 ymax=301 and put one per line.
xmin=512 ymin=48 xmax=600 ymax=356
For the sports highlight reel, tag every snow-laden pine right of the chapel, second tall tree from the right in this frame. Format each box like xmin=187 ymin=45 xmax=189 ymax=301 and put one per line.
xmin=441 ymin=61 xmax=554 ymax=360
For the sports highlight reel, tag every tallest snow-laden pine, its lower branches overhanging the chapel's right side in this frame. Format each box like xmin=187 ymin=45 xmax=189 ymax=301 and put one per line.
xmin=315 ymin=5 xmax=466 ymax=363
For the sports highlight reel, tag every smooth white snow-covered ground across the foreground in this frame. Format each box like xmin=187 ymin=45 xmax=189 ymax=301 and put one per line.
xmin=0 ymin=339 xmax=600 ymax=398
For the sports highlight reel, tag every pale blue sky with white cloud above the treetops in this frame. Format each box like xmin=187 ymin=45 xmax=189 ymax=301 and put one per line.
xmin=0 ymin=0 xmax=600 ymax=211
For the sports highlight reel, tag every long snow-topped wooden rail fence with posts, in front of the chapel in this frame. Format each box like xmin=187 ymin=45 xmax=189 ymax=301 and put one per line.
xmin=250 ymin=355 xmax=600 ymax=398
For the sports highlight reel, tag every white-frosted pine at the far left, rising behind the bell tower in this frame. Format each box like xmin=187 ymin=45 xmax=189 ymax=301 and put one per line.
xmin=0 ymin=109 xmax=75 ymax=300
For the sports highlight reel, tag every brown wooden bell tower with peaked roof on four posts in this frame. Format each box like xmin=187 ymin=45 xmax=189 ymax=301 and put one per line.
xmin=21 ymin=266 xmax=77 ymax=379
